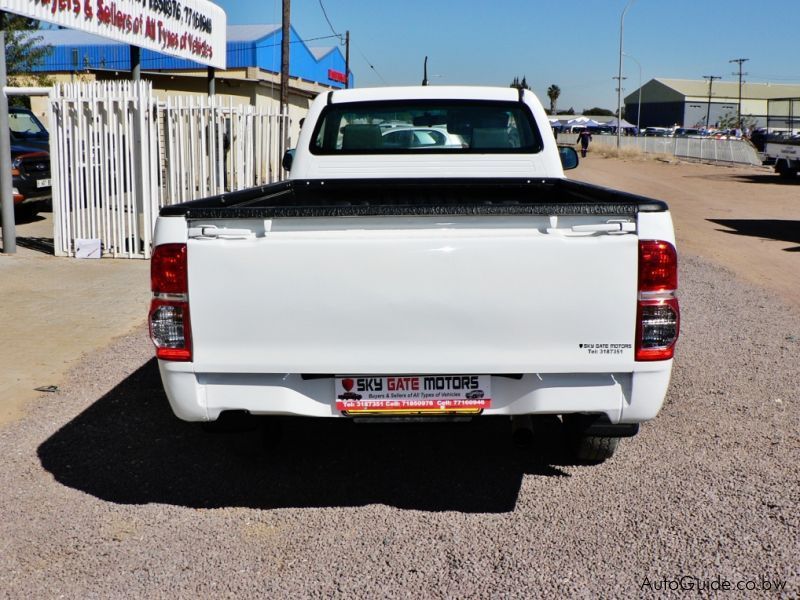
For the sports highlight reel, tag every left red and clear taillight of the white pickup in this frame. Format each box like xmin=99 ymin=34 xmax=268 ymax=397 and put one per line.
xmin=149 ymin=244 xmax=192 ymax=361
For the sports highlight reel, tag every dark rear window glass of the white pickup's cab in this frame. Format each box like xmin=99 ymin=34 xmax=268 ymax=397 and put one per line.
xmin=311 ymin=100 xmax=542 ymax=154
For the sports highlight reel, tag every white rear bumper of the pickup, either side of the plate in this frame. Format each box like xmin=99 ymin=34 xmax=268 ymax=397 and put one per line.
xmin=159 ymin=360 xmax=672 ymax=424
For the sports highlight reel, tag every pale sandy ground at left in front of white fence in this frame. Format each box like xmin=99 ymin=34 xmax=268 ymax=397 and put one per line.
xmin=0 ymin=212 xmax=150 ymax=425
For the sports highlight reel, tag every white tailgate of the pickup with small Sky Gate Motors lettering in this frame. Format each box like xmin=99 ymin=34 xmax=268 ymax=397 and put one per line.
xmin=188 ymin=216 xmax=638 ymax=374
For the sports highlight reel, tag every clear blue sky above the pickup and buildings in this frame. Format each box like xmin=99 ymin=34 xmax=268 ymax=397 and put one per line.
xmin=216 ymin=0 xmax=800 ymax=112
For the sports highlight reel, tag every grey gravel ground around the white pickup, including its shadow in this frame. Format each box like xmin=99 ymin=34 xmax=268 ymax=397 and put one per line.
xmin=0 ymin=251 xmax=800 ymax=598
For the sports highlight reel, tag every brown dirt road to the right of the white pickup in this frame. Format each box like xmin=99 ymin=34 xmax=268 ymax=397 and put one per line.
xmin=567 ymin=155 xmax=800 ymax=308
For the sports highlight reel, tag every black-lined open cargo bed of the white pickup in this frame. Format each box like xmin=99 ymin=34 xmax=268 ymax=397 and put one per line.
xmin=160 ymin=178 xmax=667 ymax=220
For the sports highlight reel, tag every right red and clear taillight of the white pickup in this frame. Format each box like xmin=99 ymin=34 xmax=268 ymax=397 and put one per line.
xmin=636 ymin=240 xmax=680 ymax=360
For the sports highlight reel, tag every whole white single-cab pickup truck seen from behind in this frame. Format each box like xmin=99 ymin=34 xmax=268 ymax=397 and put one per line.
xmin=150 ymin=87 xmax=679 ymax=462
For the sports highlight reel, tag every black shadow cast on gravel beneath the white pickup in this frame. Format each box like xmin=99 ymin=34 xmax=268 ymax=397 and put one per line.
xmin=38 ymin=359 xmax=566 ymax=513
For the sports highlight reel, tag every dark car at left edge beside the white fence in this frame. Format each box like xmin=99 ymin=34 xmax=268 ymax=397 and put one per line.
xmin=8 ymin=107 xmax=53 ymax=213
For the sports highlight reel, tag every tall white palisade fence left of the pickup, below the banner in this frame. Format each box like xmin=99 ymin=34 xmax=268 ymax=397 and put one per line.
xmin=50 ymin=81 xmax=288 ymax=258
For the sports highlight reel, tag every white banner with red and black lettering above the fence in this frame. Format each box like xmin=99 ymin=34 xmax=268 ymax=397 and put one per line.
xmin=0 ymin=0 xmax=227 ymax=69
